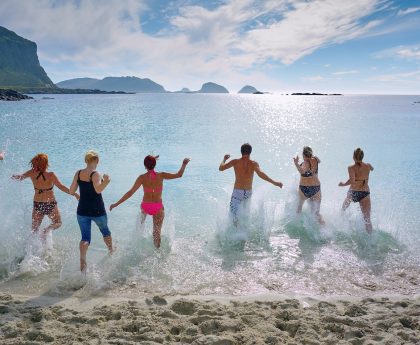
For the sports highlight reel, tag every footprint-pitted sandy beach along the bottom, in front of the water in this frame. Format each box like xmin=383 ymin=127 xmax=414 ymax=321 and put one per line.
xmin=0 ymin=294 xmax=420 ymax=345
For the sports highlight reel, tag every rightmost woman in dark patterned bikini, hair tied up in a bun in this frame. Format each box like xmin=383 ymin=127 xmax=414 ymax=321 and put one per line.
xmin=338 ymin=148 xmax=373 ymax=233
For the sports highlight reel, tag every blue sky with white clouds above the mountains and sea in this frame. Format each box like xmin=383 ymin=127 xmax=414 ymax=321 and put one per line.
xmin=0 ymin=0 xmax=420 ymax=94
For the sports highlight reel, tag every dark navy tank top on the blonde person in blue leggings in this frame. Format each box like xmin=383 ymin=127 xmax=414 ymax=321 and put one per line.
xmin=77 ymin=170 xmax=106 ymax=217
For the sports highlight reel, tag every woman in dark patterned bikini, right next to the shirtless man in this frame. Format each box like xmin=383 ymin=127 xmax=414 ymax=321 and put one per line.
xmin=293 ymin=146 xmax=325 ymax=225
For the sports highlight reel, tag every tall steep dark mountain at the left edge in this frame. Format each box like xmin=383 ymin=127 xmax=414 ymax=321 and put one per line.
xmin=0 ymin=26 xmax=55 ymax=89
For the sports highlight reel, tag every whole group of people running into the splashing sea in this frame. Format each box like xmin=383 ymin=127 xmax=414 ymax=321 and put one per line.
xmin=0 ymin=143 xmax=373 ymax=272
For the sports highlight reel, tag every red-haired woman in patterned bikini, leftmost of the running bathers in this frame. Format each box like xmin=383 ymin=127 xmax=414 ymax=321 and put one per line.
xmin=12 ymin=153 xmax=79 ymax=239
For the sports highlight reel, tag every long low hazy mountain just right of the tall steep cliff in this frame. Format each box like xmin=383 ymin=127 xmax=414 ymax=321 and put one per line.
xmin=57 ymin=77 xmax=166 ymax=93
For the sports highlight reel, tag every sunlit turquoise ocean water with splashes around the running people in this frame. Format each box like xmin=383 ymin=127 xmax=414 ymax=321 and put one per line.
xmin=0 ymin=94 xmax=420 ymax=296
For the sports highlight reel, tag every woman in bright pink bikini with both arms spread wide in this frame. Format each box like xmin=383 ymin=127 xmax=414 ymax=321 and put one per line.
xmin=110 ymin=155 xmax=190 ymax=248
